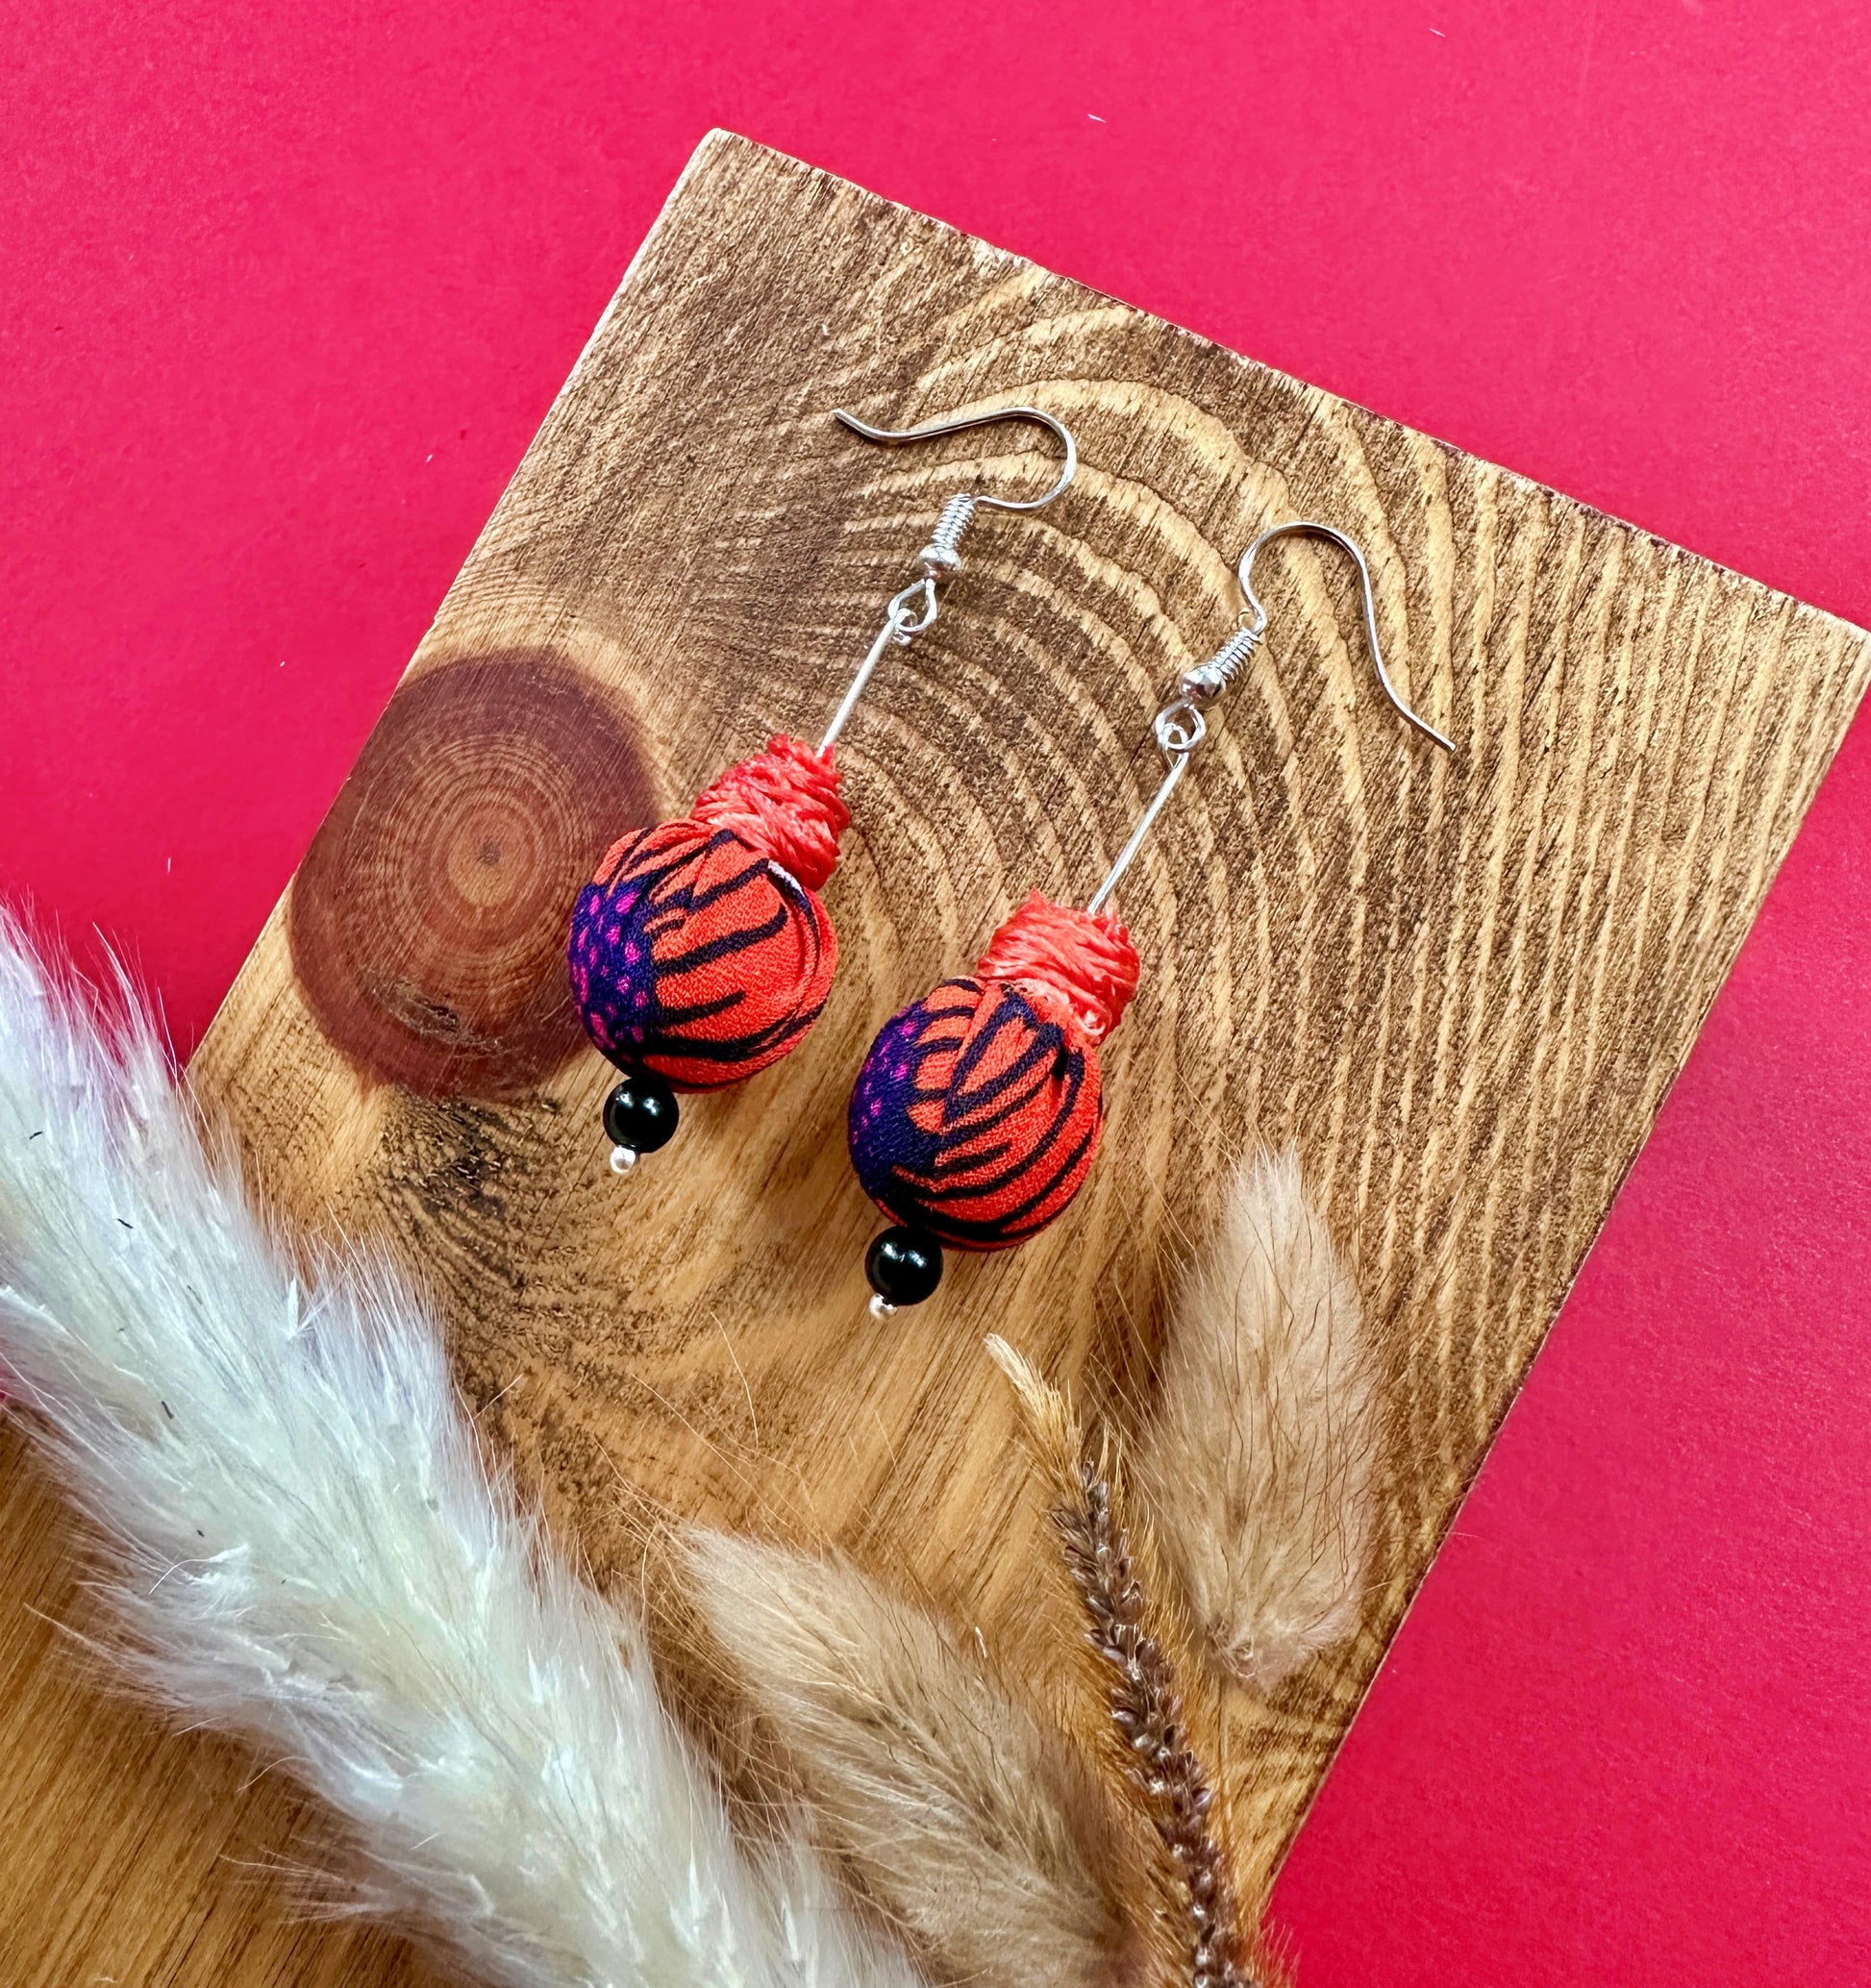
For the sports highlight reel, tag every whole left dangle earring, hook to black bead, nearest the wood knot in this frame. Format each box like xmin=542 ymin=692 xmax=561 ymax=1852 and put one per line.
xmin=568 ymin=408 xmax=1078 ymax=1173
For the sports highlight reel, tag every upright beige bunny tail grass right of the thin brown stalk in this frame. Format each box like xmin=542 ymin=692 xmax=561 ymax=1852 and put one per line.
xmin=1135 ymin=1149 xmax=1382 ymax=1692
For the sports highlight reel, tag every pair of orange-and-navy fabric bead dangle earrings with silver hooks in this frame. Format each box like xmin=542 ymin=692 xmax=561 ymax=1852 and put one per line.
xmin=571 ymin=408 xmax=1454 ymax=1316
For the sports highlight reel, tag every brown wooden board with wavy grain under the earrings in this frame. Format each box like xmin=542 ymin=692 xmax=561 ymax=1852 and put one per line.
xmin=12 ymin=134 xmax=1871 ymax=1982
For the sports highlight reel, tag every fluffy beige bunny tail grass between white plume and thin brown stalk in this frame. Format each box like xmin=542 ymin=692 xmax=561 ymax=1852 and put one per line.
xmin=684 ymin=1530 xmax=1141 ymax=1988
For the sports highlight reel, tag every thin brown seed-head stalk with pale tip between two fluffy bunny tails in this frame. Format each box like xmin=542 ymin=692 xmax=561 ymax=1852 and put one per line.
xmin=988 ymin=1338 xmax=1264 ymax=1988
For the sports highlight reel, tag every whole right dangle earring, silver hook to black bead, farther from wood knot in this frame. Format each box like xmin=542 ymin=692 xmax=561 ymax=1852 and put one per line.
xmin=849 ymin=521 xmax=1454 ymax=1318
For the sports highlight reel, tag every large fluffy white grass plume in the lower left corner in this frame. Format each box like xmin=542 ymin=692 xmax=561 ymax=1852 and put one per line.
xmin=0 ymin=916 xmax=914 ymax=1988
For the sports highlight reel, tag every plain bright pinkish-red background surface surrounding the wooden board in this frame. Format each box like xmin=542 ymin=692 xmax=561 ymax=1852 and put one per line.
xmin=0 ymin=0 xmax=1871 ymax=1988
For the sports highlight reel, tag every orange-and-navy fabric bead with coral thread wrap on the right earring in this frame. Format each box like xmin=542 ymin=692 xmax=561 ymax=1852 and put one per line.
xmin=849 ymin=895 xmax=1137 ymax=1251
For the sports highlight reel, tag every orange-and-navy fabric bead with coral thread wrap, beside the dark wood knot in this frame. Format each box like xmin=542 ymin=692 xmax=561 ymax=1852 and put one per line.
xmin=568 ymin=737 xmax=851 ymax=1091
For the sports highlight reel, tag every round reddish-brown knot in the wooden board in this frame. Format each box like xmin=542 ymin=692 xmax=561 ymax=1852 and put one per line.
xmin=287 ymin=650 xmax=656 ymax=1098
